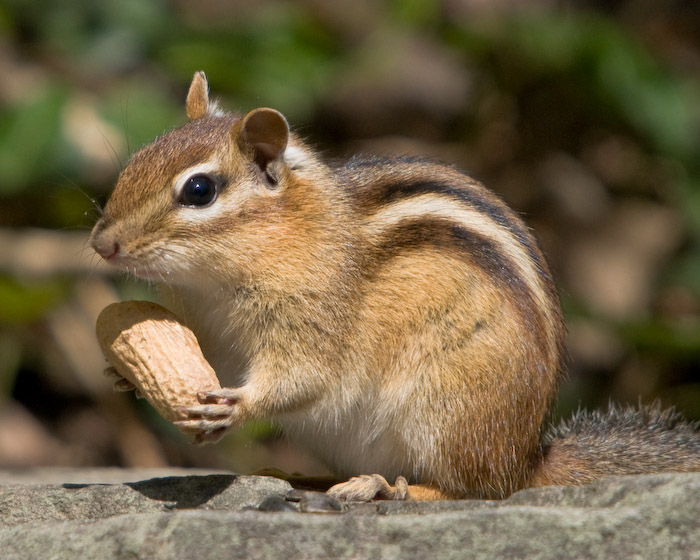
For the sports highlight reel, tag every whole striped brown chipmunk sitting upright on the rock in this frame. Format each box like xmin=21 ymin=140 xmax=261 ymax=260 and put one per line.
xmin=91 ymin=72 xmax=700 ymax=500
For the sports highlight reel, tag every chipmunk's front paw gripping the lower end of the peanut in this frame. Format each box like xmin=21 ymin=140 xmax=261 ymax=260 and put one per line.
xmin=174 ymin=389 xmax=242 ymax=444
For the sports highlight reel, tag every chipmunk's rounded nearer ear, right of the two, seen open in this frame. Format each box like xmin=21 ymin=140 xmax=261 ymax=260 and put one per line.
xmin=233 ymin=108 xmax=289 ymax=170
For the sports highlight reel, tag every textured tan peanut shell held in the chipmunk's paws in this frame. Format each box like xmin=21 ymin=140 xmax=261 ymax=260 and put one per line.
xmin=95 ymin=301 xmax=220 ymax=421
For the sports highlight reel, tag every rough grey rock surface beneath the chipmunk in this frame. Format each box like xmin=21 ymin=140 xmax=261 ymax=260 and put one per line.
xmin=0 ymin=469 xmax=700 ymax=560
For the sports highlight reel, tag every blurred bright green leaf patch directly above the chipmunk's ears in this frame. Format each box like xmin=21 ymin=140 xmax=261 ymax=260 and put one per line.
xmin=161 ymin=9 xmax=336 ymax=120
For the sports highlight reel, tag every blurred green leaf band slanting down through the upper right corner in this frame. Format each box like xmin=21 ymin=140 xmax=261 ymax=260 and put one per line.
xmin=463 ymin=11 xmax=700 ymax=162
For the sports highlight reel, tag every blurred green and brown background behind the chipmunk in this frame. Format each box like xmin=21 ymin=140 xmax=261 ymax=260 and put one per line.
xmin=0 ymin=0 xmax=700 ymax=474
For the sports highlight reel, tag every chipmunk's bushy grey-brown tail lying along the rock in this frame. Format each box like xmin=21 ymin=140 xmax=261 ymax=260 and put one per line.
xmin=529 ymin=403 xmax=700 ymax=487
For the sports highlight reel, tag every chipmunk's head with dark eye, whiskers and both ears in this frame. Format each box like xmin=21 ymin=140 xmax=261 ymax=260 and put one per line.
xmin=91 ymin=72 xmax=325 ymax=284
